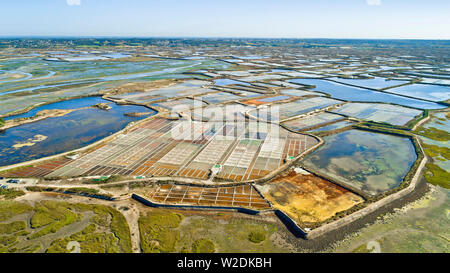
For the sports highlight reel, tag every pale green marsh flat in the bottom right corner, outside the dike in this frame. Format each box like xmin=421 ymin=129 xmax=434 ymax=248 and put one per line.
xmin=332 ymin=187 xmax=450 ymax=253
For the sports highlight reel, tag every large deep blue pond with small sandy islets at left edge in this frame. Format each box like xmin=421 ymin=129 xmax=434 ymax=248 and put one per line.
xmin=0 ymin=104 xmax=155 ymax=166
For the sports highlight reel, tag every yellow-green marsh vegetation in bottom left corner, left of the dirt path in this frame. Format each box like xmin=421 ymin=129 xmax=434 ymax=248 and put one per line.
xmin=0 ymin=200 xmax=132 ymax=253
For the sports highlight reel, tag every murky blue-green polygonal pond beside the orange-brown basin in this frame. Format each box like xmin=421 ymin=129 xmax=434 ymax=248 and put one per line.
xmin=302 ymin=130 xmax=417 ymax=196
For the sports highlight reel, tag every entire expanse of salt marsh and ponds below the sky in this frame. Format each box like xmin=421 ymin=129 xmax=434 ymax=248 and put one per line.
xmin=0 ymin=38 xmax=450 ymax=253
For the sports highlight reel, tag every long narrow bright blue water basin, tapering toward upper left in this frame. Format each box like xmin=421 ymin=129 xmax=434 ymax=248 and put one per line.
xmin=290 ymin=79 xmax=446 ymax=109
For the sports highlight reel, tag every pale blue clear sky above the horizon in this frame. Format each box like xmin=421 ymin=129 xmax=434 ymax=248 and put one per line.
xmin=0 ymin=0 xmax=450 ymax=39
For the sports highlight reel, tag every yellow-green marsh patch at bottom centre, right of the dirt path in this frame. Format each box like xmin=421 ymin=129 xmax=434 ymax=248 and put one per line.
xmin=139 ymin=209 xmax=287 ymax=253
